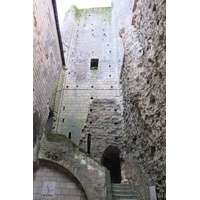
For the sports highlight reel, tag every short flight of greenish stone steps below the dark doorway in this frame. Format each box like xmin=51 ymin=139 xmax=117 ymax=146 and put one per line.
xmin=112 ymin=183 xmax=139 ymax=200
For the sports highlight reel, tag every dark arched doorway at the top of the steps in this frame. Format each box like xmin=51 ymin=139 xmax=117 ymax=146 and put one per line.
xmin=101 ymin=146 xmax=121 ymax=183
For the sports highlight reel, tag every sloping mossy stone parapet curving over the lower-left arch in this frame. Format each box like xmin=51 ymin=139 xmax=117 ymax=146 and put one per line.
xmin=38 ymin=134 xmax=112 ymax=200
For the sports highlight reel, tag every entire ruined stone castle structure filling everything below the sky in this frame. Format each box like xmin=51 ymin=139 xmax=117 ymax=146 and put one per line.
xmin=33 ymin=0 xmax=166 ymax=200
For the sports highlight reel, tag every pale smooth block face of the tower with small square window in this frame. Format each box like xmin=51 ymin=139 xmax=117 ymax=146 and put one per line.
xmin=54 ymin=6 xmax=122 ymax=144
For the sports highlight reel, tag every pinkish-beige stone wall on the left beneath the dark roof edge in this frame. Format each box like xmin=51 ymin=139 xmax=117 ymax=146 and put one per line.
xmin=33 ymin=0 xmax=62 ymax=145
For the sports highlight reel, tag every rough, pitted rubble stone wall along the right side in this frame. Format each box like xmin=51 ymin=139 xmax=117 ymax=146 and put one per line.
xmin=120 ymin=0 xmax=166 ymax=200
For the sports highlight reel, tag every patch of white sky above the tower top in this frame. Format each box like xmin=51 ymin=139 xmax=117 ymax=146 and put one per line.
xmin=56 ymin=0 xmax=111 ymax=29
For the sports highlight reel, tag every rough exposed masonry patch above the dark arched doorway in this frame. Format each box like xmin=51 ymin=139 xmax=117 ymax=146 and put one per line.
xmin=80 ymin=99 xmax=124 ymax=162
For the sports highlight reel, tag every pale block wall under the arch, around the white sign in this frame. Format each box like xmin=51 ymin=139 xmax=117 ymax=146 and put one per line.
xmin=33 ymin=160 xmax=87 ymax=200
